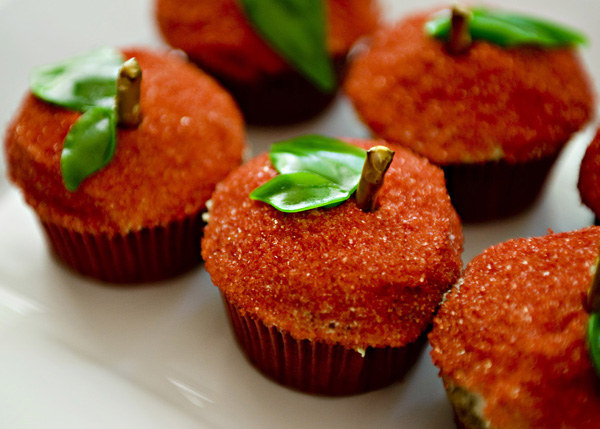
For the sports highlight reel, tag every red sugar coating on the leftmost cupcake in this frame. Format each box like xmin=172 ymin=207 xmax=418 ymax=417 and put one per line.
xmin=5 ymin=49 xmax=245 ymax=234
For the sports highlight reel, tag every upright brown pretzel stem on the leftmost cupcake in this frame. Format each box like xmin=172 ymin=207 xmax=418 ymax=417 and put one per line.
xmin=117 ymin=58 xmax=142 ymax=127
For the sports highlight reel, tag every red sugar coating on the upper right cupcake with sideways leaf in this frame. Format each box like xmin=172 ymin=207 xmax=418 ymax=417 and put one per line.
xmin=345 ymin=13 xmax=593 ymax=165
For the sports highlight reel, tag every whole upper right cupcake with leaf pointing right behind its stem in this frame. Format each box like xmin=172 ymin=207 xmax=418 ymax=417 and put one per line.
xmin=345 ymin=5 xmax=594 ymax=221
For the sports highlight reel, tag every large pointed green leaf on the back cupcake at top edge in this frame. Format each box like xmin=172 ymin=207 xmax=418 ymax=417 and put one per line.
xmin=241 ymin=0 xmax=336 ymax=92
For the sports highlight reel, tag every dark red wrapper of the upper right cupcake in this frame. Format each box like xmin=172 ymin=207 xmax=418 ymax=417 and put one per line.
xmin=442 ymin=154 xmax=558 ymax=222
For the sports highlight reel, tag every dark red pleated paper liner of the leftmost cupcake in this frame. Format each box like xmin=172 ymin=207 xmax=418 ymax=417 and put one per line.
xmin=42 ymin=215 xmax=203 ymax=283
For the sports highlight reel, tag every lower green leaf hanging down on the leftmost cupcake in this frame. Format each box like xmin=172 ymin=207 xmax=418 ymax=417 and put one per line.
xmin=60 ymin=106 xmax=116 ymax=192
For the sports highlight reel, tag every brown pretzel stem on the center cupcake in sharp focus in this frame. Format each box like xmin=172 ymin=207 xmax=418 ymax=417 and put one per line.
xmin=356 ymin=146 xmax=394 ymax=212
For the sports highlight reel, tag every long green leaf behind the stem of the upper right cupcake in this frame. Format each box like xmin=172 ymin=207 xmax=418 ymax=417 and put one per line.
xmin=425 ymin=8 xmax=587 ymax=48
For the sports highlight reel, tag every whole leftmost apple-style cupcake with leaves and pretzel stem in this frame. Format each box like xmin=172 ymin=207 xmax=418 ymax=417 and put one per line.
xmin=5 ymin=49 xmax=245 ymax=283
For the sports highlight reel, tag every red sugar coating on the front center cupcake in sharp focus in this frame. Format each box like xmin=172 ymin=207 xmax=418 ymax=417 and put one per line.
xmin=202 ymin=141 xmax=463 ymax=348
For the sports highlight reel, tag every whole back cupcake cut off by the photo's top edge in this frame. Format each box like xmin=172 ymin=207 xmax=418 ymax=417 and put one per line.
xmin=155 ymin=0 xmax=378 ymax=124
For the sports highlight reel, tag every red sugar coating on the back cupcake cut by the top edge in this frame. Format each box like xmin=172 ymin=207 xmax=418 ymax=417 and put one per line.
xmin=155 ymin=0 xmax=378 ymax=82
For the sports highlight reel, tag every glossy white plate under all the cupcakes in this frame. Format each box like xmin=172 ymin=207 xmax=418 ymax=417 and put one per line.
xmin=0 ymin=0 xmax=600 ymax=429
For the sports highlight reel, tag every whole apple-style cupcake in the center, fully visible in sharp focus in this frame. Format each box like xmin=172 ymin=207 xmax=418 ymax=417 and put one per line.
xmin=202 ymin=136 xmax=462 ymax=395
